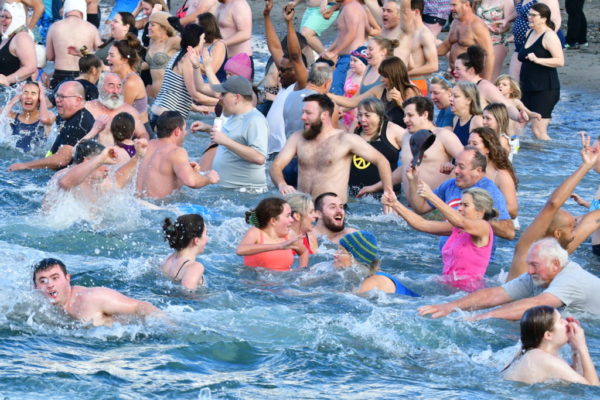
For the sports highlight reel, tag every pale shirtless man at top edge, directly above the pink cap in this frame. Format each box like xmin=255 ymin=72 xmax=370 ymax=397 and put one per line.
xmin=217 ymin=0 xmax=254 ymax=63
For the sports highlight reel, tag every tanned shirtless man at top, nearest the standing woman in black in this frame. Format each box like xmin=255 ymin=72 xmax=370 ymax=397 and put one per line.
xmin=437 ymin=0 xmax=494 ymax=80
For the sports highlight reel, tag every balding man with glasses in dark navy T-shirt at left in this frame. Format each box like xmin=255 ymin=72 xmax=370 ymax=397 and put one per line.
xmin=8 ymin=81 xmax=94 ymax=171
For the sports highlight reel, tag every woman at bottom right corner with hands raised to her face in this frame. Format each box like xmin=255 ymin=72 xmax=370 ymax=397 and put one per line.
xmin=502 ymin=306 xmax=600 ymax=386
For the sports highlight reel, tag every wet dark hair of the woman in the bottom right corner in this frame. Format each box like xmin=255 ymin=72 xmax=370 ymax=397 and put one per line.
xmin=502 ymin=306 xmax=556 ymax=371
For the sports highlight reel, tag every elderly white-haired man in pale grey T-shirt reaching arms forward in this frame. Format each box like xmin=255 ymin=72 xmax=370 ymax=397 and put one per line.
xmin=419 ymin=238 xmax=600 ymax=320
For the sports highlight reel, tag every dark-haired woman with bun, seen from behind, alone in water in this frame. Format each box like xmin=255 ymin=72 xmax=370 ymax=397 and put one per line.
xmin=160 ymin=214 xmax=208 ymax=290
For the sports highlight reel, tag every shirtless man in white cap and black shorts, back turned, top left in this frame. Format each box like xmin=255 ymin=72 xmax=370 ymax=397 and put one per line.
xmin=46 ymin=0 xmax=102 ymax=90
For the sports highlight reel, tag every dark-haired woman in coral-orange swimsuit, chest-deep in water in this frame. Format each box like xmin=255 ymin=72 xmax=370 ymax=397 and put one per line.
xmin=236 ymin=197 xmax=308 ymax=271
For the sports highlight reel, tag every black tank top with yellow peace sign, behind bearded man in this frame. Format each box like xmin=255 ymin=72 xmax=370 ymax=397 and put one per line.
xmin=348 ymin=120 xmax=400 ymax=188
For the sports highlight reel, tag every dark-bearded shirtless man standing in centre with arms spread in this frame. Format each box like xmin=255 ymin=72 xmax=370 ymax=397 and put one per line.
xmin=271 ymin=94 xmax=394 ymax=206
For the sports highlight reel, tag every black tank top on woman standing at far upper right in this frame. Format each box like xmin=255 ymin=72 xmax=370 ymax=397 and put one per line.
xmin=519 ymin=30 xmax=560 ymax=92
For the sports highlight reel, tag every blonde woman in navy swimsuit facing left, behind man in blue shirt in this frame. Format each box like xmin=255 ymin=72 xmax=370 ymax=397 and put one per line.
xmin=450 ymin=81 xmax=483 ymax=146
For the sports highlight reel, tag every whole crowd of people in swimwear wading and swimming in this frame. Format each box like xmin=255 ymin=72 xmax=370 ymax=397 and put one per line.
xmin=0 ymin=0 xmax=600 ymax=385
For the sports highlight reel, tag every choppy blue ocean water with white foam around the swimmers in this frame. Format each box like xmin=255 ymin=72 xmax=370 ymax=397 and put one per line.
xmin=0 ymin=3 xmax=600 ymax=400
